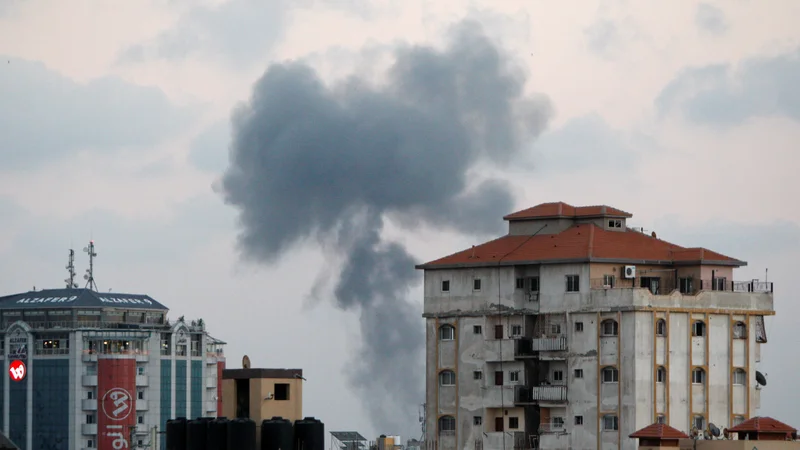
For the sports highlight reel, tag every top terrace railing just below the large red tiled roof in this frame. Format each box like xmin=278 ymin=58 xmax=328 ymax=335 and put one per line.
xmin=589 ymin=272 xmax=773 ymax=295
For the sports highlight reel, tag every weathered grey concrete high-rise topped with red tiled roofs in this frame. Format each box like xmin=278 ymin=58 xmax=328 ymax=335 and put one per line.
xmin=418 ymin=203 xmax=774 ymax=450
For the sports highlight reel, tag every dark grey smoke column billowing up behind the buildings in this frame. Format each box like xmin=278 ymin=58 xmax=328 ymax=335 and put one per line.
xmin=221 ymin=22 xmax=551 ymax=436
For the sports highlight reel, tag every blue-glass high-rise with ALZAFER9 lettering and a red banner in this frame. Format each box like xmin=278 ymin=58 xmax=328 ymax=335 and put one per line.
xmin=0 ymin=289 xmax=225 ymax=450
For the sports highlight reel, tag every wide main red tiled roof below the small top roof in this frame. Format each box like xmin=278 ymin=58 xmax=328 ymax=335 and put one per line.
xmin=417 ymin=224 xmax=746 ymax=268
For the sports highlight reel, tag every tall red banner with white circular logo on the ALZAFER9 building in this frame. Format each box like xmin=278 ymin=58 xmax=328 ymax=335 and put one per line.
xmin=97 ymin=357 xmax=136 ymax=450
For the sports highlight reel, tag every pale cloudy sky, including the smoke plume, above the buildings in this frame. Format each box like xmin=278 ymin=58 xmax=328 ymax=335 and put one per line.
xmin=0 ymin=0 xmax=800 ymax=438
